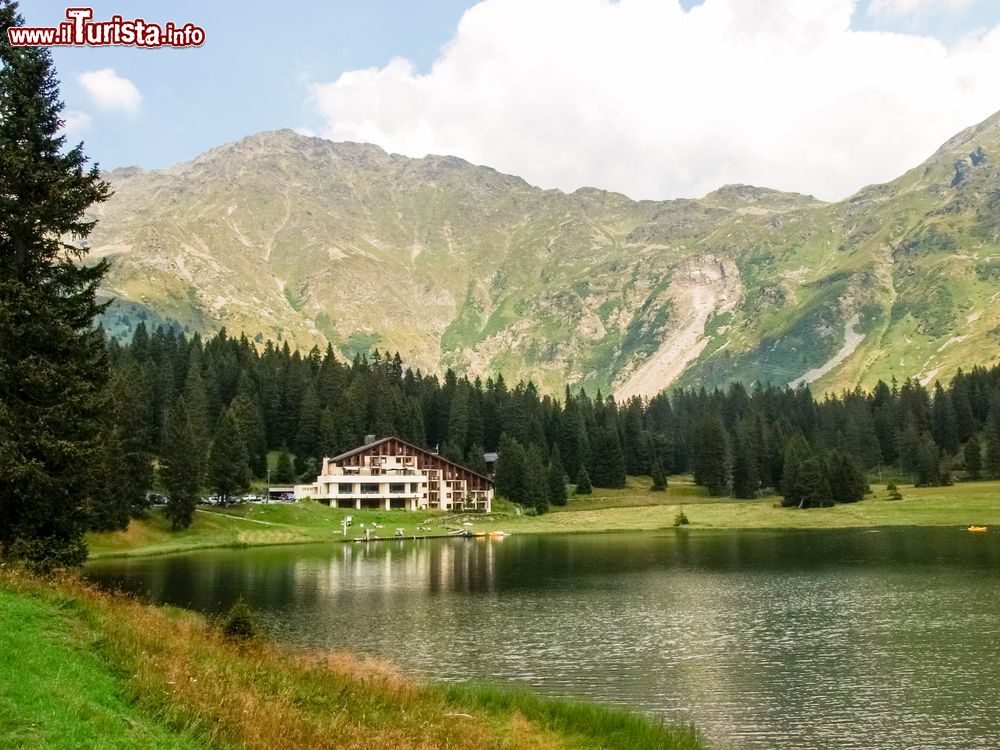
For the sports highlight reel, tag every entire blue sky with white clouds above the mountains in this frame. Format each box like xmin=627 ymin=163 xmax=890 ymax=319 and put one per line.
xmin=21 ymin=0 xmax=1000 ymax=200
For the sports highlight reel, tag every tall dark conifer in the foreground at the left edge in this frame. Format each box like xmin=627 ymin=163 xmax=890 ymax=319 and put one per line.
xmin=0 ymin=2 xmax=108 ymax=569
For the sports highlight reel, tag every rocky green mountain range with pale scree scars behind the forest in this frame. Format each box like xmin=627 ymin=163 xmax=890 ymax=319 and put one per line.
xmin=90 ymin=113 xmax=1000 ymax=397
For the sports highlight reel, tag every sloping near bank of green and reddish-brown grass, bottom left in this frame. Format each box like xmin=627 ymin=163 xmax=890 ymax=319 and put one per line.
xmin=0 ymin=570 xmax=705 ymax=750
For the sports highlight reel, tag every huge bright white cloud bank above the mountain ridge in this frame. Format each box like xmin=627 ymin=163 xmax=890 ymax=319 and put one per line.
xmin=311 ymin=0 xmax=1000 ymax=199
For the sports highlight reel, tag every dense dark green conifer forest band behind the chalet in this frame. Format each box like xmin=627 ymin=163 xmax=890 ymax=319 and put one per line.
xmin=97 ymin=324 xmax=1000 ymax=525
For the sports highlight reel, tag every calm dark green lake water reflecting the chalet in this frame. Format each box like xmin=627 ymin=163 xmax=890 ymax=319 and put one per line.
xmin=87 ymin=529 xmax=1000 ymax=750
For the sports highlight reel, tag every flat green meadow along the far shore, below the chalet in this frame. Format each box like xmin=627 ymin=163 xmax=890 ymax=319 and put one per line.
xmin=88 ymin=477 xmax=1000 ymax=558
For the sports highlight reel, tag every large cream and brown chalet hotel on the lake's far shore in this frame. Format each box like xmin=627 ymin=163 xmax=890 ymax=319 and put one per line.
xmin=295 ymin=437 xmax=493 ymax=513
